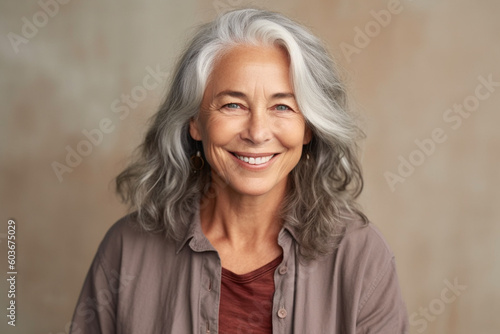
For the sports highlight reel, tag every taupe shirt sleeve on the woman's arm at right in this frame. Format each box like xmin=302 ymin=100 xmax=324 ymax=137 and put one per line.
xmin=337 ymin=217 xmax=408 ymax=333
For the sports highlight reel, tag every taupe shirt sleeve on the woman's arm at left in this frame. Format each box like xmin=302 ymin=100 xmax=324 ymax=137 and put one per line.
xmin=70 ymin=251 xmax=120 ymax=334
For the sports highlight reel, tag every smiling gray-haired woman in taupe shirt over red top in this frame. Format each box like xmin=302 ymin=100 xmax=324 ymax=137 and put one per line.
xmin=72 ymin=9 xmax=408 ymax=334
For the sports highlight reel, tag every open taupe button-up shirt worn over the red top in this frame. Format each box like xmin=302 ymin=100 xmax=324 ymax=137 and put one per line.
xmin=71 ymin=210 xmax=408 ymax=334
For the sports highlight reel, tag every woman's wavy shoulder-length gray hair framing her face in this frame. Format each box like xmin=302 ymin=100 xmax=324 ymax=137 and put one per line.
xmin=116 ymin=9 xmax=367 ymax=258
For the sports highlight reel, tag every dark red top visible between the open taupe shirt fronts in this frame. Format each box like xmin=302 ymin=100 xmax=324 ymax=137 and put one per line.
xmin=219 ymin=255 xmax=283 ymax=334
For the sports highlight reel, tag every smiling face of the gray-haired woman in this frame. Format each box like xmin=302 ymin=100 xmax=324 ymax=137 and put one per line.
xmin=190 ymin=45 xmax=311 ymax=196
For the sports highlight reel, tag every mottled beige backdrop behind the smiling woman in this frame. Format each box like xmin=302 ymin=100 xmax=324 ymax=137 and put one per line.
xmin=0 ymin=0 xmax=500 ymax=334
